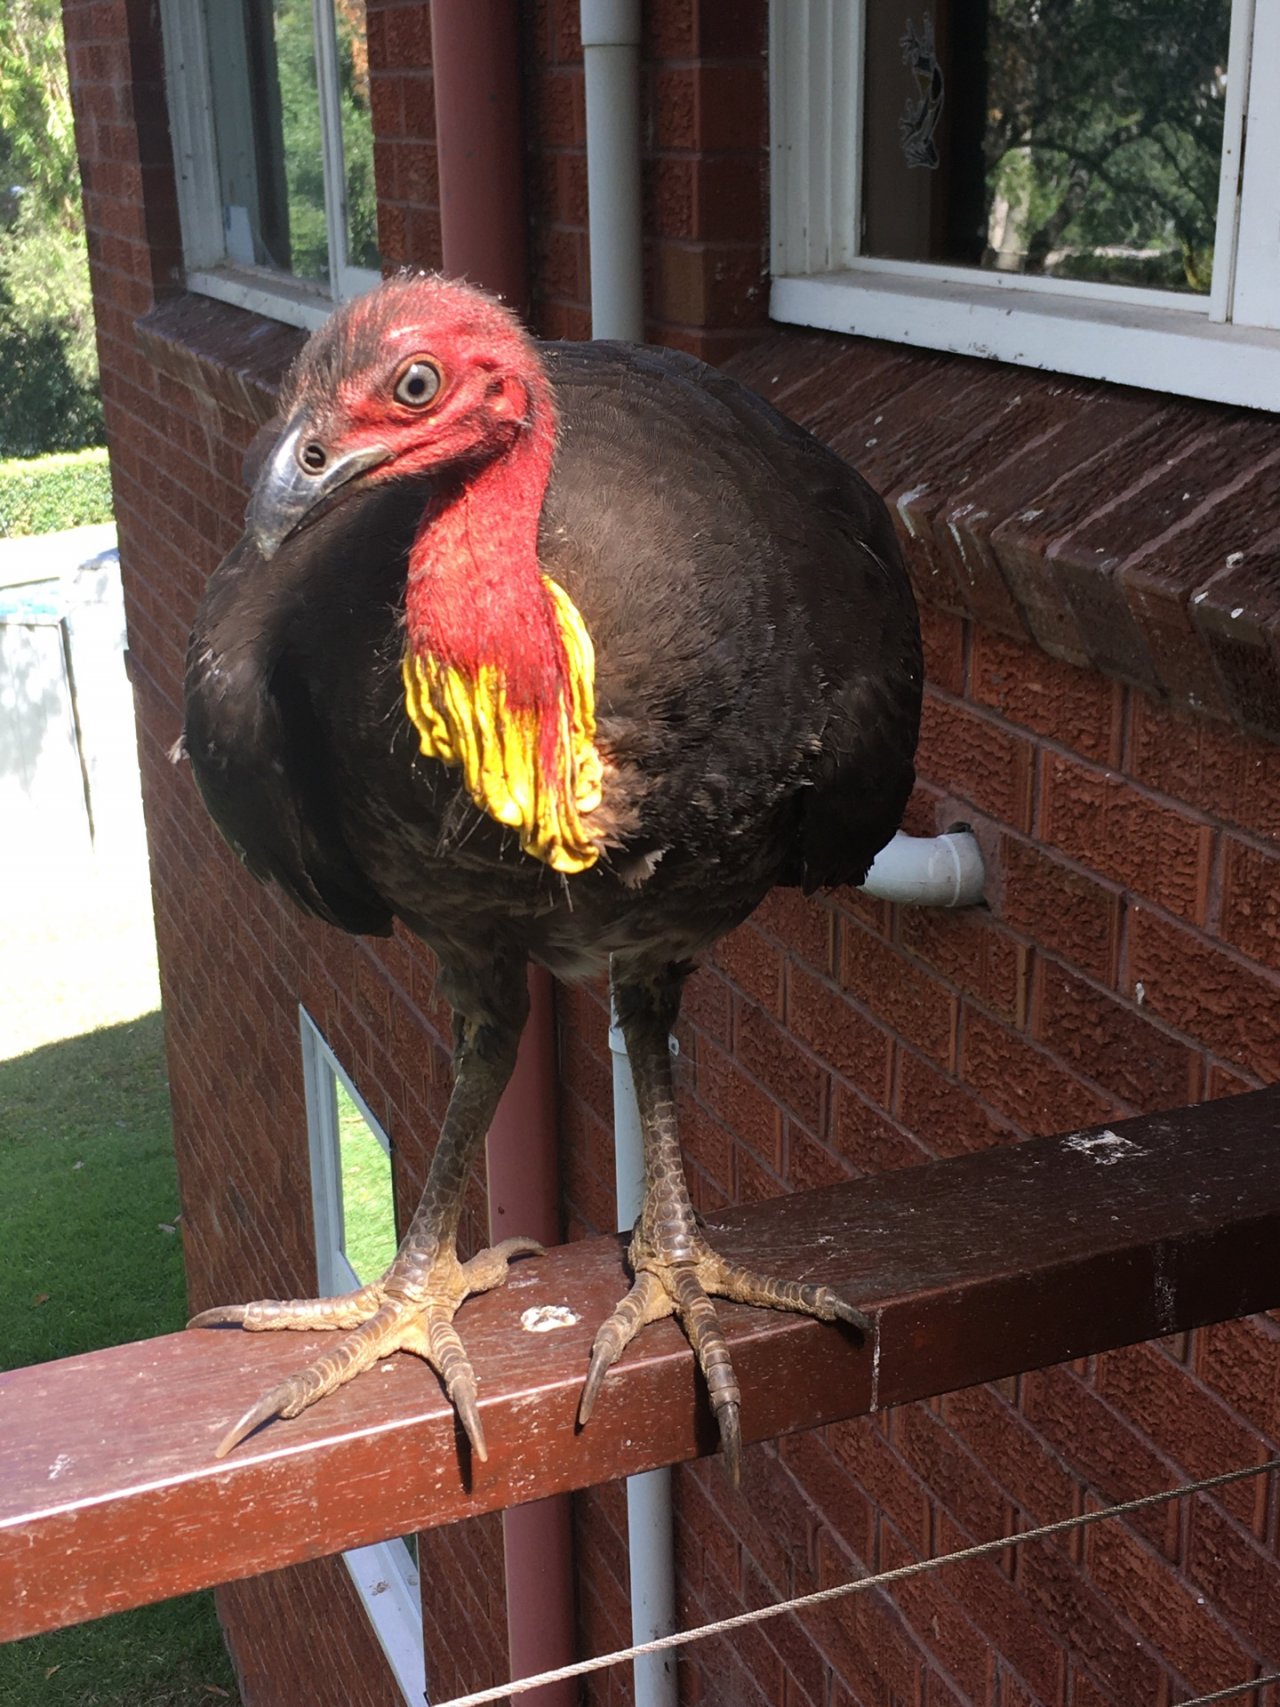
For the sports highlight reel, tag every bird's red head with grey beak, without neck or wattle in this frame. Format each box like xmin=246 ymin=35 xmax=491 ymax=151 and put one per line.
xmin=247 ymin=273 xmax=555 ymax=558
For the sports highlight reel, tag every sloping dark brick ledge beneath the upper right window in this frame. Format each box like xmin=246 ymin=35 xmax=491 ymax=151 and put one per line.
xmin=725 ymin=329 xmax=1280 ymax=741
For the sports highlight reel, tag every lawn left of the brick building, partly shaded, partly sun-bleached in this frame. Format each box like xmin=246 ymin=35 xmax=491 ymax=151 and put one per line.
xmin=0 ymin=853 xmax=239 ymax=1707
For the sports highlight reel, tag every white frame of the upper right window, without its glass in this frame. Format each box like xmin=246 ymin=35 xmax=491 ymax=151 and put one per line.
xmin=770 ymin=0 xmax=1280 ymax=410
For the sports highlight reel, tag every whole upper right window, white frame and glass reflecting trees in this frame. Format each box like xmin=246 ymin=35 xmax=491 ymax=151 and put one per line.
xmin=770 ymin=0 xmax=1280 ymax=408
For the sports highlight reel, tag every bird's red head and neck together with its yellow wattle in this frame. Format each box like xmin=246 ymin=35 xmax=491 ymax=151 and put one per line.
xmin=247 ymin=275 xmax=602 ymax=872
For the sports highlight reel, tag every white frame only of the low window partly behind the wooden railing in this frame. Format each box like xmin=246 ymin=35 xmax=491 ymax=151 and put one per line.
xmin=299 ymin=1007 xmax=427 ymax=1707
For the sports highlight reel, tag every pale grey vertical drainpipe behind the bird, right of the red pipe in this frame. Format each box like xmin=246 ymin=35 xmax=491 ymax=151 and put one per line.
xmin=580 ymin=10 xmax=676 ymax=1707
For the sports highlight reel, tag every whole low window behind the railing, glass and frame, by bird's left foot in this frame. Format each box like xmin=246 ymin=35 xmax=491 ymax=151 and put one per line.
xmin=299 ymin=1007 xmax=427 ymax=1707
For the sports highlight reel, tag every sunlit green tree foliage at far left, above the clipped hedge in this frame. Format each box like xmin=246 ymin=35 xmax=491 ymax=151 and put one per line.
xmin=0 ymin=0 xmax=102 ymax=456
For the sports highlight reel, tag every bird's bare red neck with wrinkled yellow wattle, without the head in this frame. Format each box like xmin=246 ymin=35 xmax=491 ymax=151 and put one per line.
xmin=404 ymin=374 xmax=601 ymax=872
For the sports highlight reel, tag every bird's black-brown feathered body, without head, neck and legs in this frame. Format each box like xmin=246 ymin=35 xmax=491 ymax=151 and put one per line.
xmin=186 ymin=332 xmax=920 ymax=996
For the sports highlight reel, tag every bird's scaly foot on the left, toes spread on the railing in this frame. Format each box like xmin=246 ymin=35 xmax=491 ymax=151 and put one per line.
xmin=188 ymin=1238 xmax=543 ymax=1459
